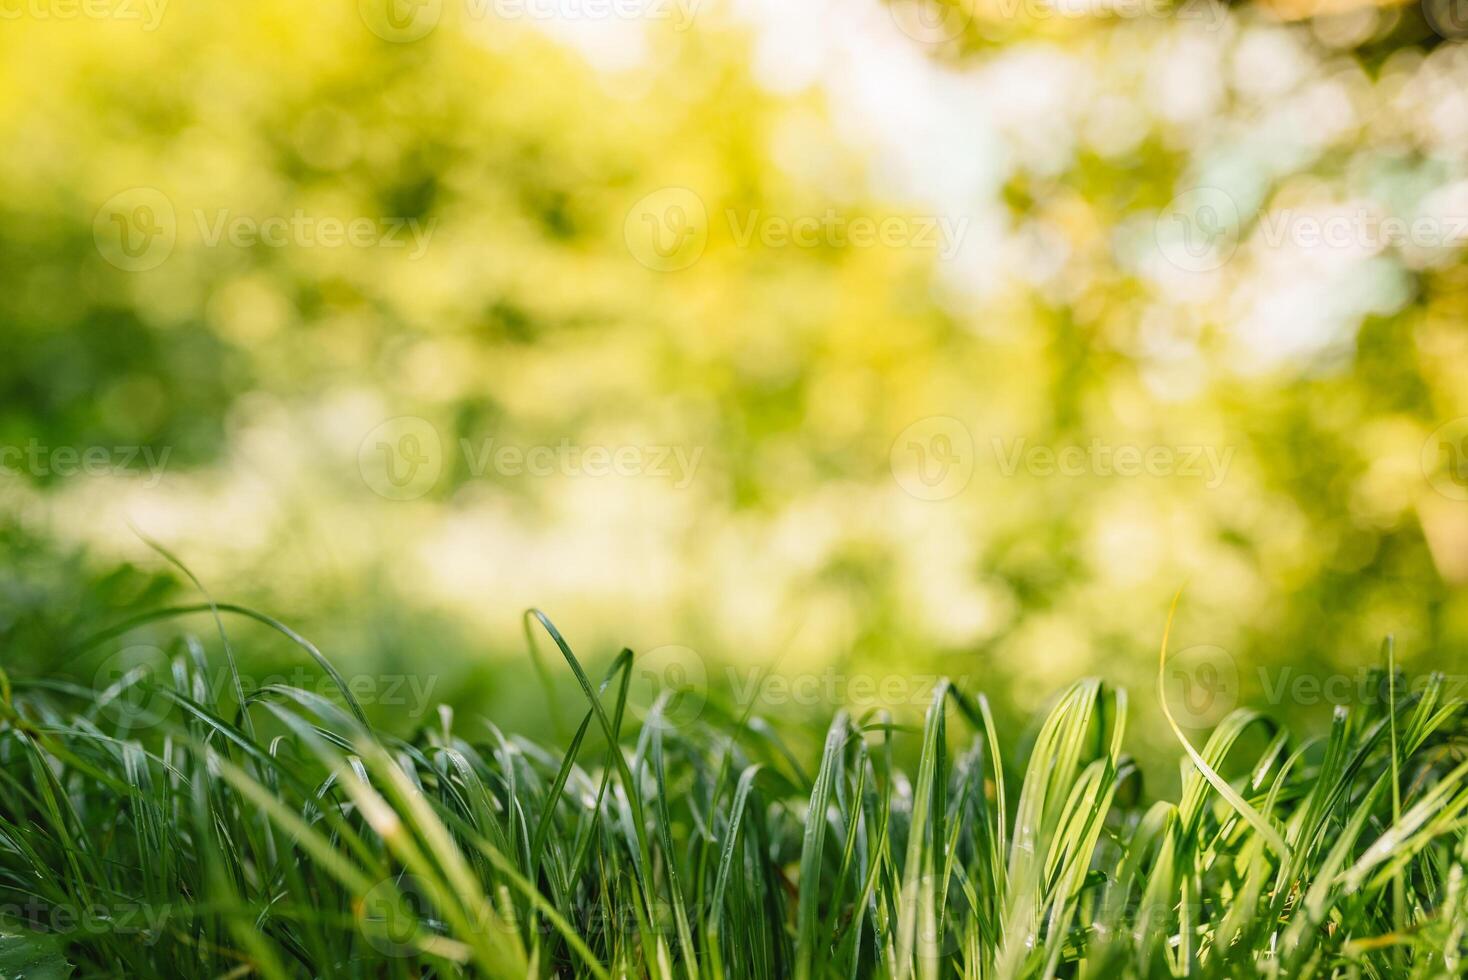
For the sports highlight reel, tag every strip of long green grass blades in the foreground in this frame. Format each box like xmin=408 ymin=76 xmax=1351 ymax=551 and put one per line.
xmin=0 ymin=606 xmax=1468 ymax=980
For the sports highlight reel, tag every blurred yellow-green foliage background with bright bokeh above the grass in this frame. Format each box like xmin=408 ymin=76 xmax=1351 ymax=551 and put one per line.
xmin=0 ymin=0 xmax=1468 ymax=756
